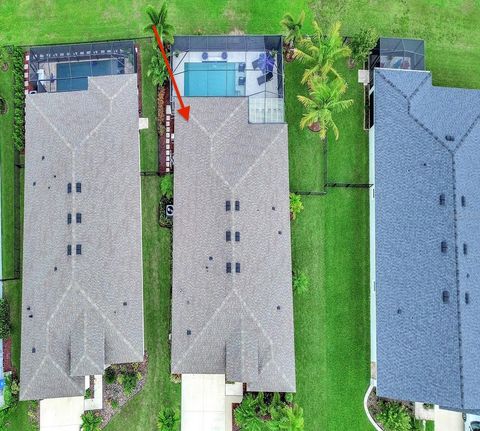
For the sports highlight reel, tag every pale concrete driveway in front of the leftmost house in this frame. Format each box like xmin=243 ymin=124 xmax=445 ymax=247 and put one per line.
xmin=40 ymin=397 xmax=84 ymax=431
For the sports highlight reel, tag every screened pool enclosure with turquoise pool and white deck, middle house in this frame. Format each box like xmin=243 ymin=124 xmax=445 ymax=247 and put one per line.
xmin=170 ymin=36 xmax=284 ymax=123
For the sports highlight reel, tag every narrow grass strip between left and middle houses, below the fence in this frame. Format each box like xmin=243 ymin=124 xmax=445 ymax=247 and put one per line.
xmin=106 ymin=177 xmax=180 ymax=431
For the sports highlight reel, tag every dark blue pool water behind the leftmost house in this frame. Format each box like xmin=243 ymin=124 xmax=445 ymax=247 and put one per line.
xmin=56 ymin=60 xmax=125 ymax=91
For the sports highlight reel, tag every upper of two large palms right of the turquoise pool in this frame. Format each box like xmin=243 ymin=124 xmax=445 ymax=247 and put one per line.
xmin=294 ymin=21 xmax=351 ymax=84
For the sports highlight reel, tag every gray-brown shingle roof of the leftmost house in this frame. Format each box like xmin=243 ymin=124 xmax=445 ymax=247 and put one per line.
xmin=20 ymin=75 xmax=144 ymax=400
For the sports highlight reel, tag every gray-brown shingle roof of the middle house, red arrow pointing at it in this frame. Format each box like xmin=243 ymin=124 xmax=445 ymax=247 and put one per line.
xmin=172 ymin=97 xmax=295 ymax=392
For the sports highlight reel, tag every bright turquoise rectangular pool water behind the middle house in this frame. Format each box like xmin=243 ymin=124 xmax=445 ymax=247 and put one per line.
xmin=183 ymin=61 xmax=238 ymax=96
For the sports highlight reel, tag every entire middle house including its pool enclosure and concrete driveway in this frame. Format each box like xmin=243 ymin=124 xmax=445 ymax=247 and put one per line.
xmin=172 ymin=36 xmax=295 ymax=431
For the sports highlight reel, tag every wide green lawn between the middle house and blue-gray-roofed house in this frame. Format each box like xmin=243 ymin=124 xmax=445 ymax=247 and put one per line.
xmin=286 ymin=52 xmax=371 ymax=431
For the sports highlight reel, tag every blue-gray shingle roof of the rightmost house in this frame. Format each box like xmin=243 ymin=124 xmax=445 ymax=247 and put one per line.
xmin=374 ymin=69 xmax=480 ymax=410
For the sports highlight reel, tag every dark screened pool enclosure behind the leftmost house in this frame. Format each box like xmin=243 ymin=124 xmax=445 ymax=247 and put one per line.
xmin=28 ymin=41 xmax=136 ymax=93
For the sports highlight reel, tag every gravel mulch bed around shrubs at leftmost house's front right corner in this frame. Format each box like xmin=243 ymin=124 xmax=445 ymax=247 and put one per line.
xmin=98 ymin=353 xmax=148 ymax=428
